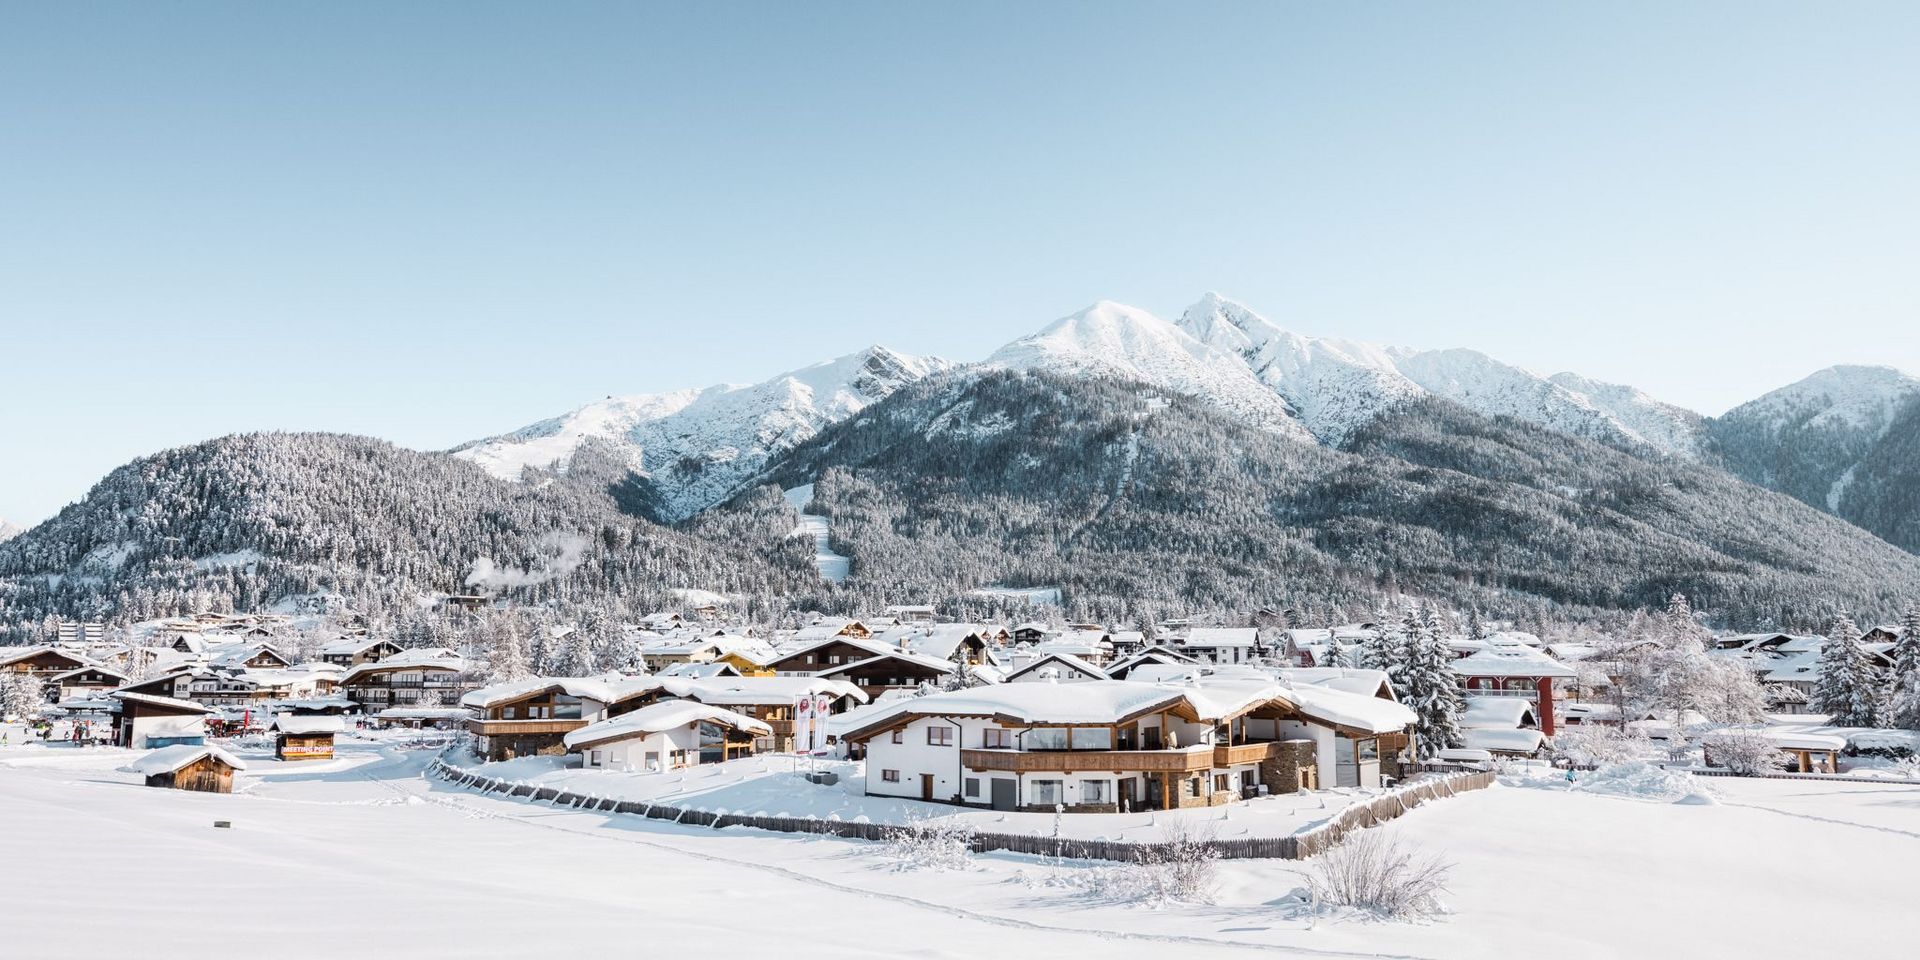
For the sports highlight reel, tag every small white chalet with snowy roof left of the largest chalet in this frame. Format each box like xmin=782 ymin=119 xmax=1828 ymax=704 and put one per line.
xmin=566 ymin=701 xmax=774 ymax=772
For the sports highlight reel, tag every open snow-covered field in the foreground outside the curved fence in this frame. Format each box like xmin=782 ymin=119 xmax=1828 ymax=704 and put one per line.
xmin=0 ymin=728 xmax=1920 ymax=960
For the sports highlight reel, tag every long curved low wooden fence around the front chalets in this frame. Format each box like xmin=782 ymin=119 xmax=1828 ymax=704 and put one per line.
xmin=432 ymin=758 xmax=1494 ymax=862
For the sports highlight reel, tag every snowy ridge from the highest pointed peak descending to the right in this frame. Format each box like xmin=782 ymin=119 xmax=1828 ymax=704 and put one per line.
xmin=1181 ymin=294 xmax=1699 ymax=457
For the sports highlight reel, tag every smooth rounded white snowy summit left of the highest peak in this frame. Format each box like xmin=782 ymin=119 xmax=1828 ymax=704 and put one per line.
xmin=985 ymin=300 xmax=1311 ymax=440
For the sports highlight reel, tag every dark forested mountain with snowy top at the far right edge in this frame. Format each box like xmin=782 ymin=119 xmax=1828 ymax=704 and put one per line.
xmin=1711 ymin=367 xmax=1920 ymax=549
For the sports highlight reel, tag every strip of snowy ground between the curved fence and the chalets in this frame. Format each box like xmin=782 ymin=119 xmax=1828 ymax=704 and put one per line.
xmin=470 ymin=755 xmax=1380 ymax=843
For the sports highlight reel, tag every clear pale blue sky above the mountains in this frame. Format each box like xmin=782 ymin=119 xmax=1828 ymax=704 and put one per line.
xmin=0 ymin=2 xmax=1920 ymax=520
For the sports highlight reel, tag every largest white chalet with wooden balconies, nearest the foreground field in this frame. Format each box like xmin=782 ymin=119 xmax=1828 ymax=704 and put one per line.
xmin=843 ymin=680 xmax=1413 ymax=812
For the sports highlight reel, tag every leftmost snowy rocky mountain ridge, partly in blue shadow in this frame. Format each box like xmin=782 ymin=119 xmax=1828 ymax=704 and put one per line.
xmin=453 ymin=346 xmax=948 ymax=520
